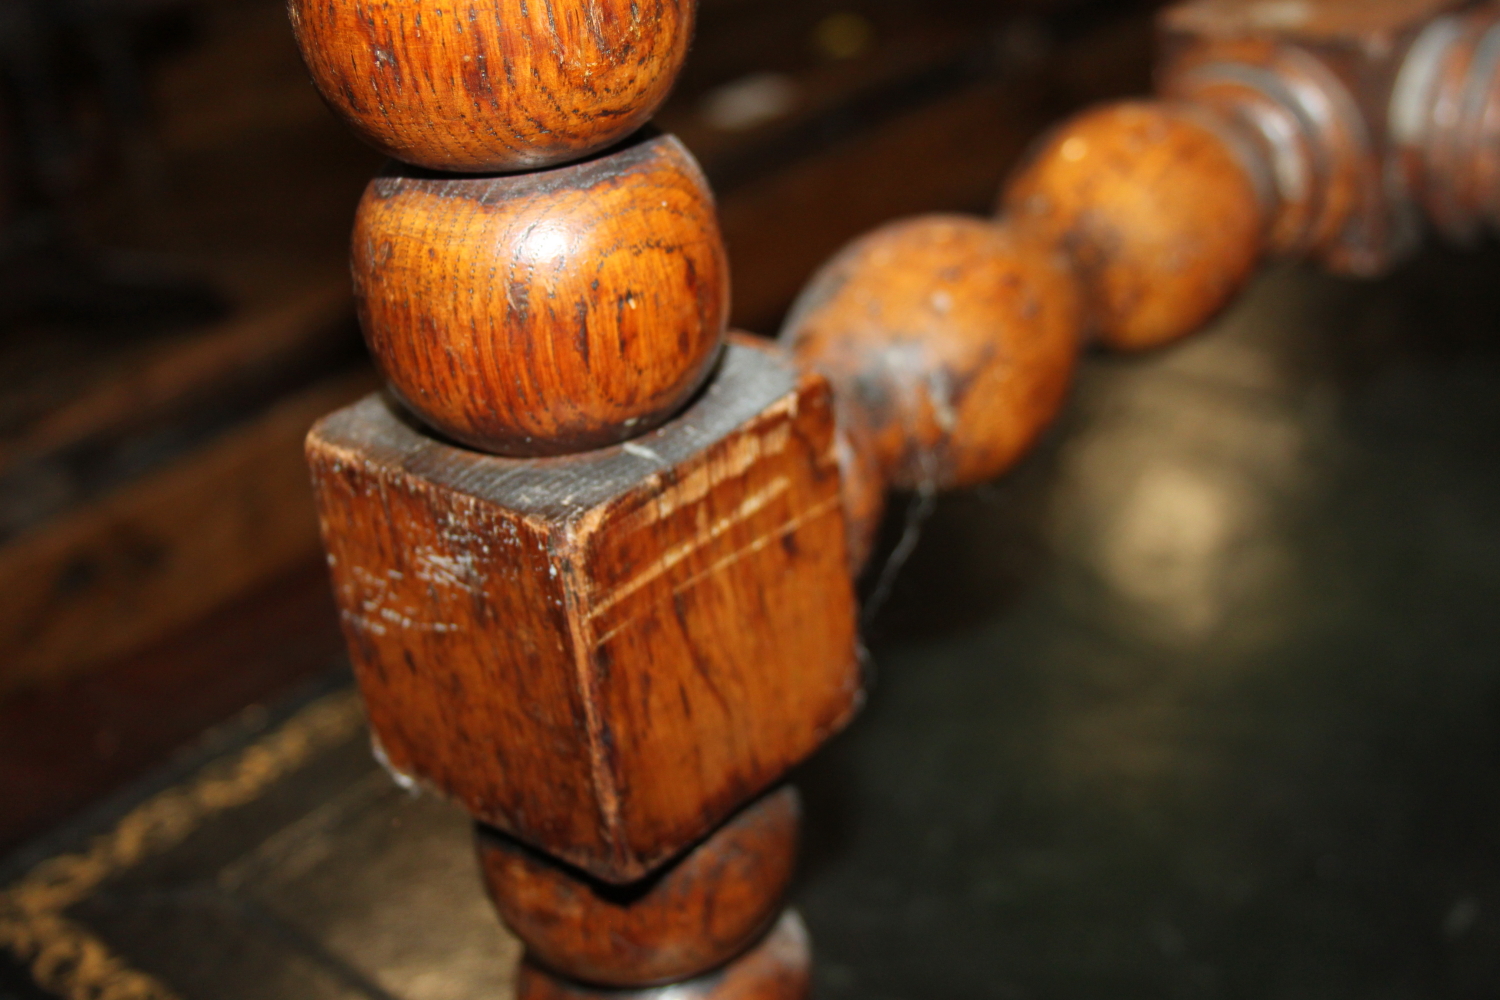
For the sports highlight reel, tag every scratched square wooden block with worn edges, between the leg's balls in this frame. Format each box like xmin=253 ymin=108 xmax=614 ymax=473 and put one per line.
xmin=309 ymin=340 xmax=861 ymax=883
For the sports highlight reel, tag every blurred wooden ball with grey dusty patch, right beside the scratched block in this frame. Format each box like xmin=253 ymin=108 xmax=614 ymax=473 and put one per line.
xmin=782 ymin=216 xmax=1083 ymax=489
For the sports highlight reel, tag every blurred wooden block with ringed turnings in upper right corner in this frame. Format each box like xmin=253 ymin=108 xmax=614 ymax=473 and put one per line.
xmin=1158 ymin=0 xmax=1500 ymax=277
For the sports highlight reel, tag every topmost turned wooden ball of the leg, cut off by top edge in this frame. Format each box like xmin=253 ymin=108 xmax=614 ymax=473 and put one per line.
xmin=288 ymin=0 xmax=696 ymax=171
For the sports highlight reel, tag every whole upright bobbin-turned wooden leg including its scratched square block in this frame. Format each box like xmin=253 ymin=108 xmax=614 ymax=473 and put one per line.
xmin=290 ymin=0 xmax=860 ymax=1000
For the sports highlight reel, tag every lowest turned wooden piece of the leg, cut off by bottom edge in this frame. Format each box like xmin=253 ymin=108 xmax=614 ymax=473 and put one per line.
xmin=516 ymin=912 xmax=813 ymax=1000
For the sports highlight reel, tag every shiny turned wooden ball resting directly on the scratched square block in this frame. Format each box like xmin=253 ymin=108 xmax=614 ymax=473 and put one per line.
xmin=354 ymin=136 xmax=729 ymax=457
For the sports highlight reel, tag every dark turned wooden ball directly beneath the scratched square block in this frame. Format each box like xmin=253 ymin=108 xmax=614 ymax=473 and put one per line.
xmin=477 ymin=786 xmax=801 ymax=987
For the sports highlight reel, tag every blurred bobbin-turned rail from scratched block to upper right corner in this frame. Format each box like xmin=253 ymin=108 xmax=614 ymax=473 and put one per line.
xmin=783 ymin=0 xmax=1500 ymax=524
